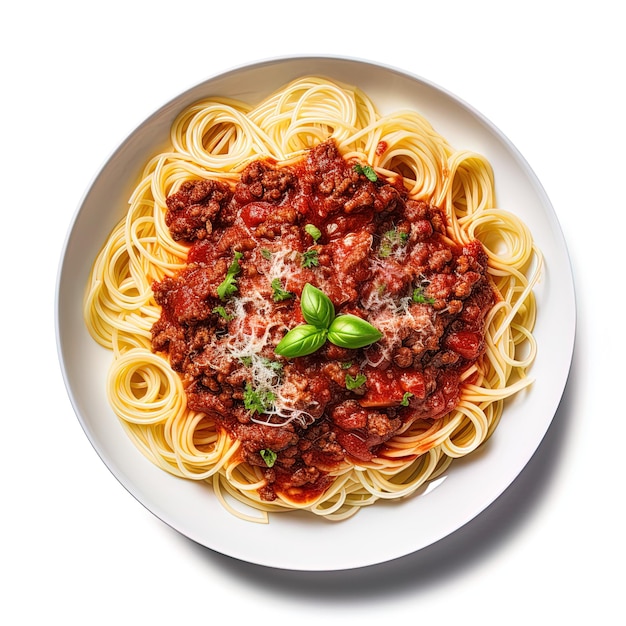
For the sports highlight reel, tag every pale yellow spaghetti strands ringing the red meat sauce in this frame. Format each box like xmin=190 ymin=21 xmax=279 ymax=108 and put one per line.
xmin=84 ymin=77 xmax=541 ymax=522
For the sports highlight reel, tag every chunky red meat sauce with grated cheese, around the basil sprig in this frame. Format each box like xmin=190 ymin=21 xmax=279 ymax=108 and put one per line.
xmin=152 ymin=141 xmax=496 ymax=501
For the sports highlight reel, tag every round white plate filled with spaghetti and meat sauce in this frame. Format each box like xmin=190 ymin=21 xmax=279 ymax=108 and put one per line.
xmin=56 ymin=57 xmax=575 ymax=570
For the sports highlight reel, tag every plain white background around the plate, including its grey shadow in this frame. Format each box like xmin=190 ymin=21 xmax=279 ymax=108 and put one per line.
xmin=0 ymin=0 xmax=626 ymax=625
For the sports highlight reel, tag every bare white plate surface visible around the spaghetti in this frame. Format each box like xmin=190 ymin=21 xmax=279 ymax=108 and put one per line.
xmin=56 ymin=57 xmax=576 ymax=571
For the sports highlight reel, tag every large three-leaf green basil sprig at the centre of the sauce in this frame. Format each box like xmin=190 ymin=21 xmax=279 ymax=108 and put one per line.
xmin=274 ymin=283 xmax=383 ymax=358
